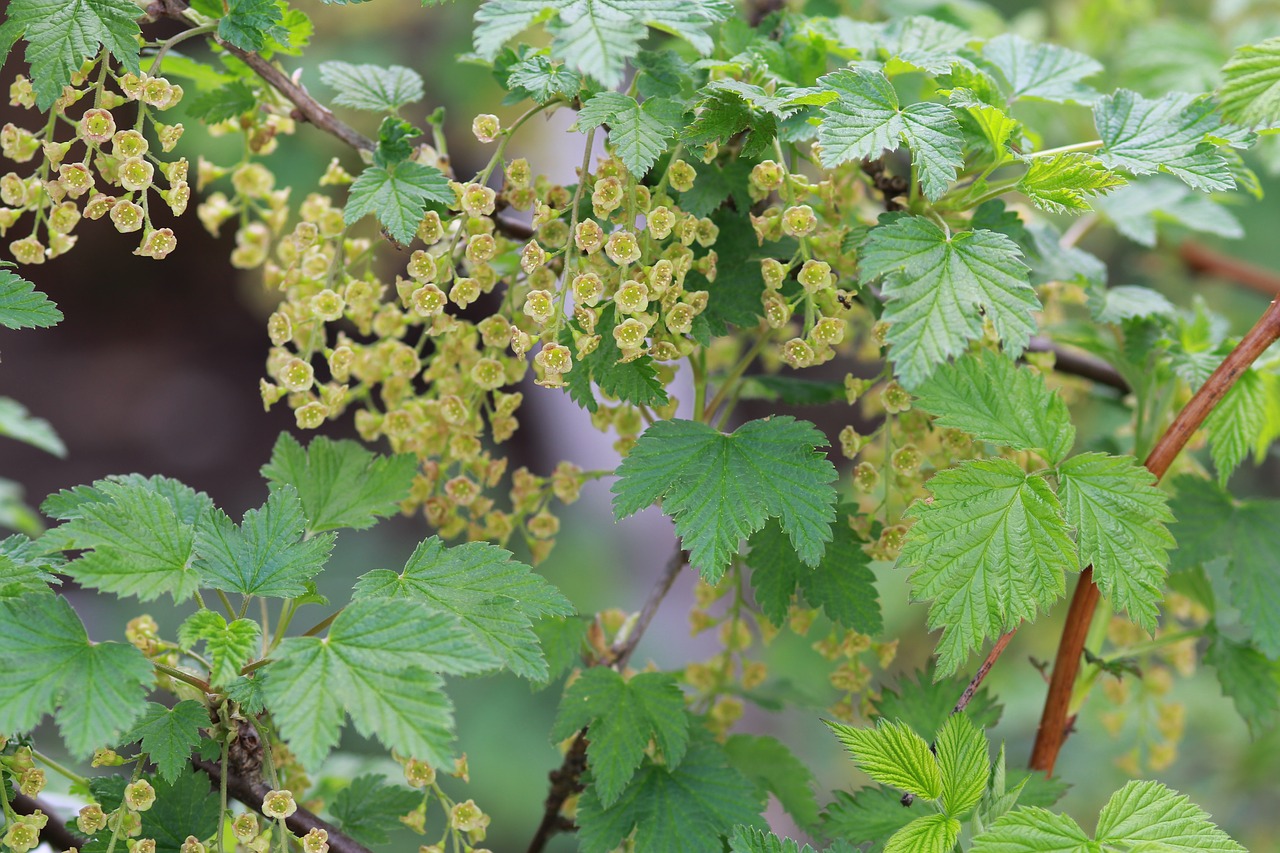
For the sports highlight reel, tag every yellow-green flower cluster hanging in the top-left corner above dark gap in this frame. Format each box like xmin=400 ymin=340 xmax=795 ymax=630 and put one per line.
xmin=0 ymin=56 xmax=191 ymax=264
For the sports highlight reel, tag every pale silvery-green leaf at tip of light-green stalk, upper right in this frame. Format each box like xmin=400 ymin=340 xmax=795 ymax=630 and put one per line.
xmin=1093 ymin=88 xmax=1235 ymax=192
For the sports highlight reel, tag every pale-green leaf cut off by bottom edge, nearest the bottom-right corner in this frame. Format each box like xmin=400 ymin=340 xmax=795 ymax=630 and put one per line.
xmin=1096 ymin=781 xmax=1245 ymax=853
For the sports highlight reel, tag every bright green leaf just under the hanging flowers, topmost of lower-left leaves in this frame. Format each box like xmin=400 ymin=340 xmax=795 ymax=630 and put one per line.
xmin=262 ymin=433 xmax=417 ymax=533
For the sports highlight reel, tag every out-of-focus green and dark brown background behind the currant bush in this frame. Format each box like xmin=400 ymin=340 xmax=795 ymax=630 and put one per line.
xmin=0 ymin=0 xmax=1280 ymax=852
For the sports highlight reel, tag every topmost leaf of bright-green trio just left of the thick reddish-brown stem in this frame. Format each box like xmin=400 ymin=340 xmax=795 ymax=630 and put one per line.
xmin=914 ymin=350 xmax=1075 ymax=464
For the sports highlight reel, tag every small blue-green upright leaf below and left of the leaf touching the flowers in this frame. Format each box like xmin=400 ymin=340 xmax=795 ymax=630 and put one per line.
xmin=196 ymin=485 xmax=334 ymax=598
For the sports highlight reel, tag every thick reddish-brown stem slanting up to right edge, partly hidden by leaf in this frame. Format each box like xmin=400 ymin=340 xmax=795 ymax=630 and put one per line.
xmin=1030 ymin=295 xmax=1280 ymax=775
